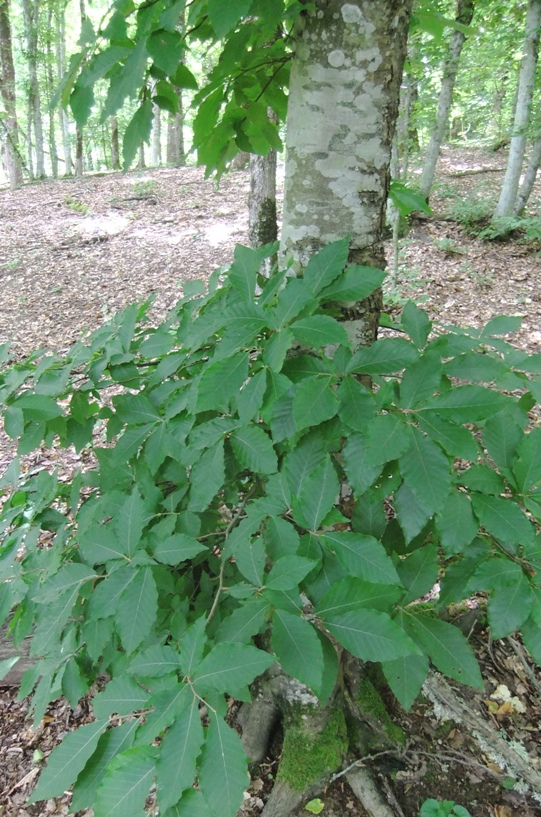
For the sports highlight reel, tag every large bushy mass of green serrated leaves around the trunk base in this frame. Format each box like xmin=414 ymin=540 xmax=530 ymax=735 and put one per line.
xmin=0 ymin=241 xmax=541 ymax=817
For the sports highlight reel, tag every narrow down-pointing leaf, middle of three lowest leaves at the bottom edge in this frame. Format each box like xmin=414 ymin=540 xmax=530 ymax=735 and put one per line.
xmin=156 ymin=699 xmax=204 ymax=812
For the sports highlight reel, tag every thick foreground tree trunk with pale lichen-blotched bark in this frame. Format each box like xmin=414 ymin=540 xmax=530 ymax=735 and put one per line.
xmin=280 ymin=0 xmax=410 ymax=344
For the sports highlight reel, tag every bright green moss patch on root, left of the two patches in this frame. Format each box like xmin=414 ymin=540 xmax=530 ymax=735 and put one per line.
xmin=277 ymin=708 xmax=348 ymax=791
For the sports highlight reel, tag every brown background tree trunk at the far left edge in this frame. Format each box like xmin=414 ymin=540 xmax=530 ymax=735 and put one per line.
xmin=0 ymin=0 xmax=23 ymax=187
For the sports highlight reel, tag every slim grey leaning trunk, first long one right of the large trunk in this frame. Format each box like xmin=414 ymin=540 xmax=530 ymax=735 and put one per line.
xmin=419 ymin=0 xmax=474 ymax=200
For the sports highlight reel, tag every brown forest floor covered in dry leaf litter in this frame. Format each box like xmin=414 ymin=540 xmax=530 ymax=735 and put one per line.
xmin=0 ymin=148 xmax=541 ymax=817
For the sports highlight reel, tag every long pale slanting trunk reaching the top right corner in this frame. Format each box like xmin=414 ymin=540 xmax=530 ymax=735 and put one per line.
xmin=494 ymin=0 xmax=541 ymax=219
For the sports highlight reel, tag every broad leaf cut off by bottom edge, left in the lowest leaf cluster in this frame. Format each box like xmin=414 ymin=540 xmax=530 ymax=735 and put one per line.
xmin=93 ymin=746 xmax=155 ymax=817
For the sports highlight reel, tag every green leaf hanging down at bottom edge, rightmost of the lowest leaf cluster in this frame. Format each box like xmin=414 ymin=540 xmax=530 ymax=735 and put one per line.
xmin=198 ymin=715 xmax=249 ymax=817
